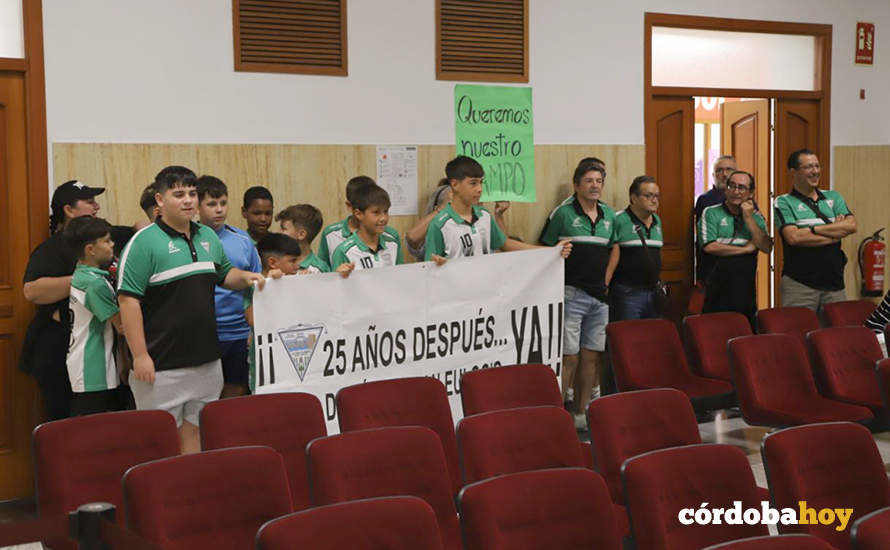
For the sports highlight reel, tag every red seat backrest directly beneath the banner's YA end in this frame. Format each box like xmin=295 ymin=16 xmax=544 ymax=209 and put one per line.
xmin=460 ymin=364 xmax=562 ymax=416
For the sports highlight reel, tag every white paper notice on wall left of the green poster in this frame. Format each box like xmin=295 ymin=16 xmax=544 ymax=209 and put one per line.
xmin=377 ymin=145 xmax=417 ymax=216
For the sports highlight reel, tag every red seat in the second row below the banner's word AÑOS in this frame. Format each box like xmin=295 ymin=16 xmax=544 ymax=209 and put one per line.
xmin=307 ymin=432 xmax=461 ymax=550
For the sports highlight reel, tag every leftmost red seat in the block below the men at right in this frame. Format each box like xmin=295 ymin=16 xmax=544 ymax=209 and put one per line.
xmin=606 ymin=319 xmax=734 ymax=411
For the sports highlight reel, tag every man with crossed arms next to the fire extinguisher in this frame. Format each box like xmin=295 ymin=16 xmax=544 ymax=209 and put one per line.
xmin=775 ymin=149 xmax=857 ymax=313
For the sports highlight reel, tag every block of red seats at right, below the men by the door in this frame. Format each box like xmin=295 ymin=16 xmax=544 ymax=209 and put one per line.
xmin=607 ymin=308 xmax=890 ymax=429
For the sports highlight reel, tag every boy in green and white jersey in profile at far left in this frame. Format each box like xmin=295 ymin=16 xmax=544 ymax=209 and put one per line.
xmin=63 ymin=216 xmax=123 ymax=416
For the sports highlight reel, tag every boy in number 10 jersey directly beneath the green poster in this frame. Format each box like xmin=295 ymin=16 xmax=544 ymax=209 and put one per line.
xmin=425 ymin=155 xmax=572 ymax=262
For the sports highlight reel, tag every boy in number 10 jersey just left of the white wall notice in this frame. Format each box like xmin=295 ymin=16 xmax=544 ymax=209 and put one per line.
xmin=331 ymin=185 xmax=403 ymax=277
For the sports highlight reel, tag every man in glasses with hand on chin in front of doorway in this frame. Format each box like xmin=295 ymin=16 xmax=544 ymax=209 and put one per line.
xmin=698 ymin=170 xmax=773 ymax=327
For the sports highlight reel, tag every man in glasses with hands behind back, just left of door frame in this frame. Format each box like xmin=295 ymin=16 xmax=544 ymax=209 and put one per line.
xmin=609 ymin=176 xmax=664 ymax=321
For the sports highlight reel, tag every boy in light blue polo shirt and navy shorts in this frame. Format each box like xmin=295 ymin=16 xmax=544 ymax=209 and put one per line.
xmin=196 ymin=176 xmax=262 ymax=398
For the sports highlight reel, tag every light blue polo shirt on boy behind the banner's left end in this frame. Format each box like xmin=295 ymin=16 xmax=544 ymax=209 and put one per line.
xmin=214 ymin=225 xmax=263 ymax=342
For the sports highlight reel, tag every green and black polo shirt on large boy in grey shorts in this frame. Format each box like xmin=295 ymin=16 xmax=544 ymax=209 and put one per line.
xmin=118 ymin=219 xmax=232 ymax=371
